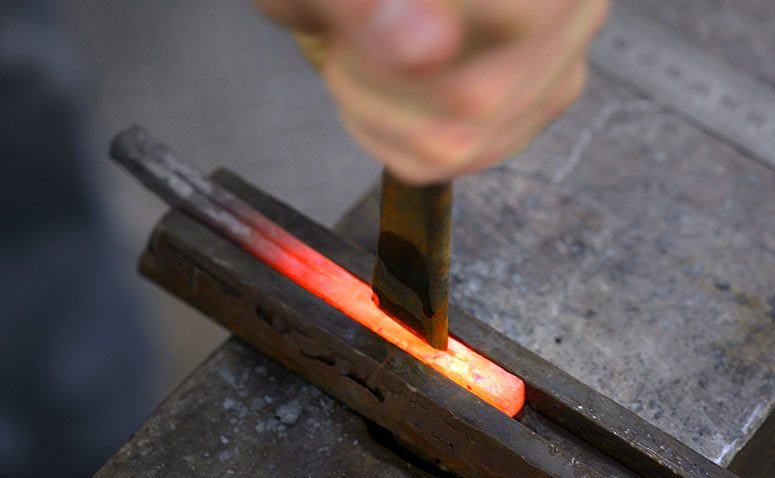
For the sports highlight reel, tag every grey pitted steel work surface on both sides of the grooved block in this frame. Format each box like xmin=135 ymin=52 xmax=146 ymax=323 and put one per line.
xmin=101 ymin=0 xmax=775 ymax=476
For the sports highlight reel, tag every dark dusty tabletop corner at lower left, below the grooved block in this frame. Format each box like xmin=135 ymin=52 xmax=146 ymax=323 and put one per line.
xmin=96 ymin=340 xmax=435 ymax=478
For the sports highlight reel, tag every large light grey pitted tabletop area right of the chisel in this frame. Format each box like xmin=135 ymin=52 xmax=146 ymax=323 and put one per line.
xmin=450 ymin=69 xmax=775 ymax=464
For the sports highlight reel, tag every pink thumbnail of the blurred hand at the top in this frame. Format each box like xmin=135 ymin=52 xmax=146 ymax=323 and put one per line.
xmin=366 ymin=0 xmax=445 ymax=65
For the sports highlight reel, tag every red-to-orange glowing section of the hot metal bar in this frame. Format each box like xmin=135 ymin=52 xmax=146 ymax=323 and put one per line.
xmin=240 ymin=212 xmax=525 ymax=416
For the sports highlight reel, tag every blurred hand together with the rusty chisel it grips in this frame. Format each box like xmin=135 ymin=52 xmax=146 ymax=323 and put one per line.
xmin=257 ymin=0 xmax=607 ymax=349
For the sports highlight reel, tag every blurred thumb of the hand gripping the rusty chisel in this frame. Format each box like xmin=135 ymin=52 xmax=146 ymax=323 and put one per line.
xmin=324 ymin=0 xmax=463 ymax=70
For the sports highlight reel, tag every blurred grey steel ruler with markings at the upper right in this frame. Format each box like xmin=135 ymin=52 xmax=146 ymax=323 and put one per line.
xmin=590 ymin=2 xmax=775 ymax=172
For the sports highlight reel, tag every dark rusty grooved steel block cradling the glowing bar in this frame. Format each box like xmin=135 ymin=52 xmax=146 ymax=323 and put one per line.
xmin=114 ymin=127 xmax=733 ymax=477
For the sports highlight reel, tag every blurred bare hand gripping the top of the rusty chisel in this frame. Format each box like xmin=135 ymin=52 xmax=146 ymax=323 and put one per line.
xmin=257 ymin=0 xmax=608 ymax=184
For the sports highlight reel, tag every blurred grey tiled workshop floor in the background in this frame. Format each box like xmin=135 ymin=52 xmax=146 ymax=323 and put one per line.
xmin=62 ymin=0 xmax=379 ymax=408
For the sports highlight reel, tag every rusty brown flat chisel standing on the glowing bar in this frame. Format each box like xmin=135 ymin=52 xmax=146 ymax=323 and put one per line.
xmin=372 ymin=170 xmax=452 ymax=350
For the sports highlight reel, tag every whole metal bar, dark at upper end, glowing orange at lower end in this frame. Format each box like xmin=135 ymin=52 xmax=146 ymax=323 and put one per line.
xmin=111 ymin=127 xmax=525 ymax=416
